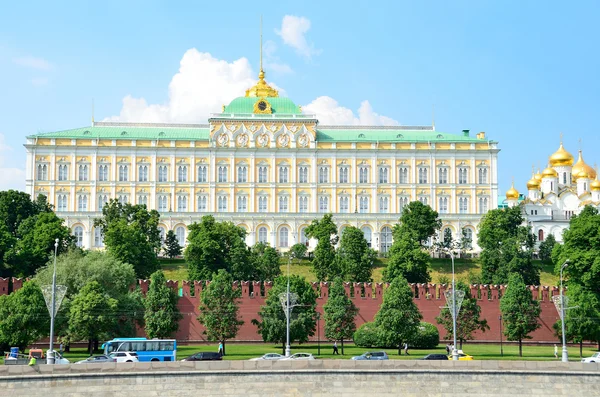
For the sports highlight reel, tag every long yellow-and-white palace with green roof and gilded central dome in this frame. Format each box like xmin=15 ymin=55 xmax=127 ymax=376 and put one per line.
xmin=25 ymin=68 xmax=499 ymax=252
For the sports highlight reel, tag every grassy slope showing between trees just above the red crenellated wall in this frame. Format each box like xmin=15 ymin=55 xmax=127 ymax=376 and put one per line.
xmin=161 ymin=258 xmax=558 ymax=286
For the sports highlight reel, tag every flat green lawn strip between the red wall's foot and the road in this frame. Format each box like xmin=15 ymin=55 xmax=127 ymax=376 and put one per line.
xmin=17 ymin=342 xmax=596 ymax=362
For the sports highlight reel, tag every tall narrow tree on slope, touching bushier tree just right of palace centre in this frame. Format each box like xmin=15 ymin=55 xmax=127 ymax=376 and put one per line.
xmin=305 ymin=214 xmax=340 ymax=281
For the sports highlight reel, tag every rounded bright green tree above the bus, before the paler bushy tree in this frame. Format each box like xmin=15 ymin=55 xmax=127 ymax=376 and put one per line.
xmin=69 ymin=281 xmax=118 ymax=355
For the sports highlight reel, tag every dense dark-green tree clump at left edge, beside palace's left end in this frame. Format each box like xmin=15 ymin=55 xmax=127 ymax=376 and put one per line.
xmin=0 ymin=190 xmax=75 ymax=277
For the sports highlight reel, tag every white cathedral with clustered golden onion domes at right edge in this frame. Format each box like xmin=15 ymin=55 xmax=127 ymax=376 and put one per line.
xmin=506 ymin=142 xmax=600 ymax=243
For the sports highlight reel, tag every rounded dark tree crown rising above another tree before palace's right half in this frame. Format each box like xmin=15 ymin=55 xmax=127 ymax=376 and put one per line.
xmin=399 ymin=201 xmax=442 ymax=245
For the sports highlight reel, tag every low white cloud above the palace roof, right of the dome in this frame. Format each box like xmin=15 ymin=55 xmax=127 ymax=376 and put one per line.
xmin=302 ymin=96 xmax=400 ymax=125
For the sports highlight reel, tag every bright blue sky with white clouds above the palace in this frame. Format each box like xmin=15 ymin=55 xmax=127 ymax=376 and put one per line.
xmin=0 ymin=0 xmax=600 ymax=196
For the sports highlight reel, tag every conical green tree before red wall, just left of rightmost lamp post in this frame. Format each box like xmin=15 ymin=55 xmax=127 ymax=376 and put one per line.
xmin=500 ymin=273 xmax=540 ymax=357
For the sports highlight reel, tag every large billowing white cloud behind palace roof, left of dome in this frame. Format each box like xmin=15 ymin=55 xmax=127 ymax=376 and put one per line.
xmin=107 ymin=48 xmax=283 ymax=123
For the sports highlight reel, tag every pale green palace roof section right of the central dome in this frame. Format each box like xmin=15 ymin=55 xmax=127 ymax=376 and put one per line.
xmin=317 ymin=127 xmax=489 ymax=142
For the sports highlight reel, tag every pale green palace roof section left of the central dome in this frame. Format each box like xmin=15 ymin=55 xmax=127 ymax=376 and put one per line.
xmin=28 ymin=125 xmax=210 ymax=141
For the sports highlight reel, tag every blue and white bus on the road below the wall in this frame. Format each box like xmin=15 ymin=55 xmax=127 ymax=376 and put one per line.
xmin=102 ymin=338 xmax=177 ymax=361
